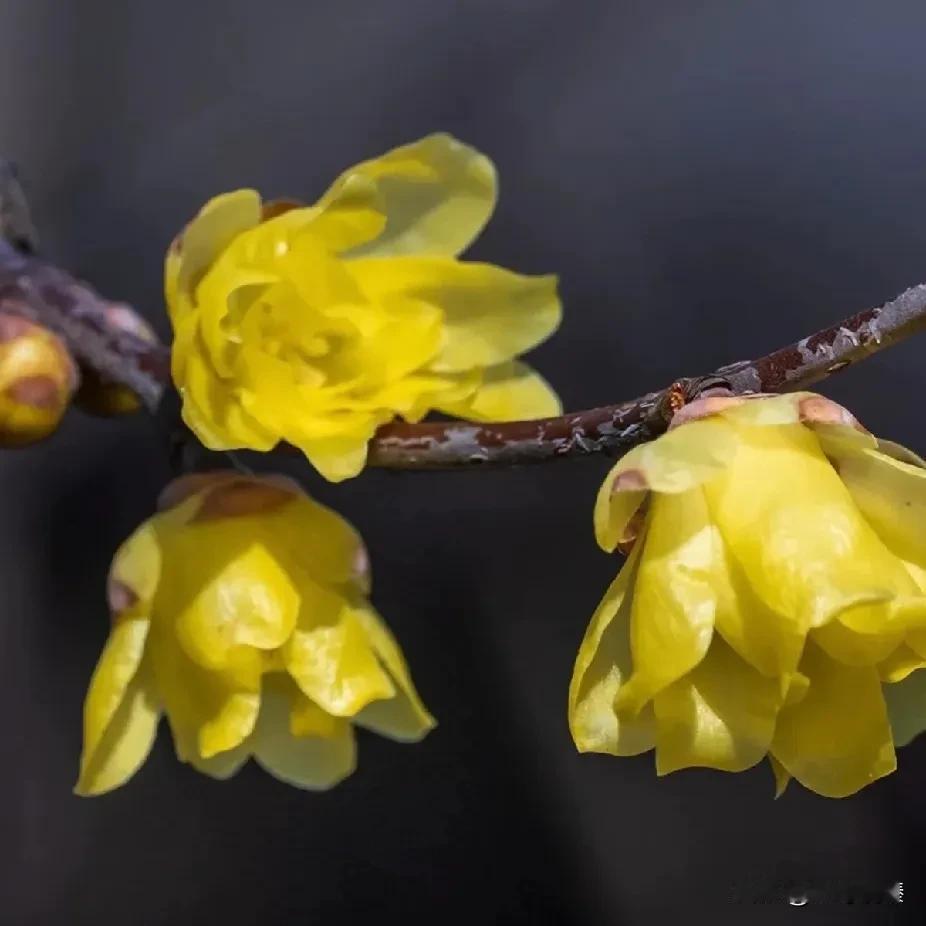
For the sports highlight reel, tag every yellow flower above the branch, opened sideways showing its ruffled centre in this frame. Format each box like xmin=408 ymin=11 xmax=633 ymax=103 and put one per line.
xmin=165 ymin=134 xmax=561 ymax=481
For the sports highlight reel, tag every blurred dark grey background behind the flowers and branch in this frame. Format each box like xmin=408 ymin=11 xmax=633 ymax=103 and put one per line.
xmin=0 ymin=0 xmax=926 ymax=926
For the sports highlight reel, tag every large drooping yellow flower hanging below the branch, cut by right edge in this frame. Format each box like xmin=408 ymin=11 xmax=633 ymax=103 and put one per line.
xmin=569 ymin=393 xmax=926 ymax=797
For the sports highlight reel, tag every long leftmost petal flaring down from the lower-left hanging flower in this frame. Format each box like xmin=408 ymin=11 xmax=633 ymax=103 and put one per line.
xmin=77 ymin=619 xmax=159 ymax=794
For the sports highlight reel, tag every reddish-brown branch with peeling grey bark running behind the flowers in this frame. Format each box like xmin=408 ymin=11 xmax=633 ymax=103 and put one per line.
xmin=0 ymin=197 xmax=926 ymax=469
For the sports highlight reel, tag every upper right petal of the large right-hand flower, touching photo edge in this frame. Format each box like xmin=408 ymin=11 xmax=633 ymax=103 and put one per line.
xmin=838 ymin=450 xmax=926 ymax=566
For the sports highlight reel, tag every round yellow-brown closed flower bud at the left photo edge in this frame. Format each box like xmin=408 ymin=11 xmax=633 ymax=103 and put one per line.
xmin=0 ymin=313 xmax=77 ymax=447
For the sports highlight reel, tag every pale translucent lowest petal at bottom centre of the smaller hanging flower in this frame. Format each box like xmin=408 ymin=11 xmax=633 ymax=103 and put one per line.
xmin=253 ymin=676 xmax=356 ymax=791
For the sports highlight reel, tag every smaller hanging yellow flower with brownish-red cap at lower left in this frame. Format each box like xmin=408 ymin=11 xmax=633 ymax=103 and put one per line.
xmin=76 ymin=473 xmax=434 ymax=795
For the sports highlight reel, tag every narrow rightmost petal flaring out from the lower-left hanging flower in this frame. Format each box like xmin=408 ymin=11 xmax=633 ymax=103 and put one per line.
xmin=354 ymin=605 xmax=436 ymax=742
